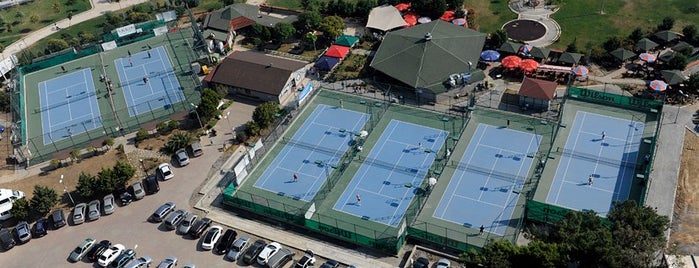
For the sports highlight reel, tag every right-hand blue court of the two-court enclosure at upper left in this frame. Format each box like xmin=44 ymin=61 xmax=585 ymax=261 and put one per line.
xmin=114 ymin=46 xmax=184 ymax=117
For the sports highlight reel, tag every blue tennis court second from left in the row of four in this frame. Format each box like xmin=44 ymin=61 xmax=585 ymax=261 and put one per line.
xmin=333 ymin=120 xmax=449 ymax=227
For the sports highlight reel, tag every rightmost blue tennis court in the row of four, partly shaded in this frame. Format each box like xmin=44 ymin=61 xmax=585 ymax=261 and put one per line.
xmin=546 ymin=111 xmax=645 ymax=216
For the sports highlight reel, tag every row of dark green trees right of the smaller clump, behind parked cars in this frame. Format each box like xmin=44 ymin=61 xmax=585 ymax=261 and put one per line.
xmin=75 ymin=161 xmax=136 ymax=198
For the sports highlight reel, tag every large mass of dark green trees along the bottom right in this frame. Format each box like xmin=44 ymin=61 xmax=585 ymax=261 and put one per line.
xmin=460 ymin=200 xmax=670 ymax=268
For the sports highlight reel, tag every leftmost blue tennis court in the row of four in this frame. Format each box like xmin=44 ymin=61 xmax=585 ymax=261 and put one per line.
xmin=254 ymin=105 xmax=369 ymax=201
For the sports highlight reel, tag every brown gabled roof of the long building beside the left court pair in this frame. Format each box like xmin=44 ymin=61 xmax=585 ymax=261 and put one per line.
xmin=210 ymin=51 xmax=306 ymax=96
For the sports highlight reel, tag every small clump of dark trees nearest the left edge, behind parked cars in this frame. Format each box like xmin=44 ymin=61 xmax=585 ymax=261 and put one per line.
xmin=10 ymin=185 xmax=58 ymax=220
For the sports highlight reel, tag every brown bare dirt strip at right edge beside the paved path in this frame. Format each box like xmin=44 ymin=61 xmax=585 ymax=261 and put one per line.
xmin=670 ymin=130 xmax=699 ymax=254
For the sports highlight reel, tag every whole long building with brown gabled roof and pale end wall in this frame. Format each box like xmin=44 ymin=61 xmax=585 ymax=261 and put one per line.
xmin=204 ymin=51 xmax=310 ymax=105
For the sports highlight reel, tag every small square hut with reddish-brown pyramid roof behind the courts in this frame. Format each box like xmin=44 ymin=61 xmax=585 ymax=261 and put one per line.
xmin=519 ymin=77 xmax=558 ymax=110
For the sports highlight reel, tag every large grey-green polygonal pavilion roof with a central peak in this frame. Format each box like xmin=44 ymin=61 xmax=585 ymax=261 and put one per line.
xmin=371 ymin=20 xmax=485 ymax=93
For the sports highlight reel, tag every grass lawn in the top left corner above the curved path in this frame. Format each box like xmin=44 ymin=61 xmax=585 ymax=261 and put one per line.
xmin=0 ymin=0 xmax=90 ymax=49
